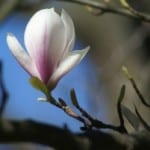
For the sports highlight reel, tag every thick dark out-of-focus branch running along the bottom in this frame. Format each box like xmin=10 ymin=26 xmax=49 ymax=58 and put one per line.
xmin=0 ymin=119 xmax=150 ymax=150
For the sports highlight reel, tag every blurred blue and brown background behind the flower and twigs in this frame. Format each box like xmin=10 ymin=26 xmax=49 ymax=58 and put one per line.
xmin=0 ymin=0 xmax=150 ymax=149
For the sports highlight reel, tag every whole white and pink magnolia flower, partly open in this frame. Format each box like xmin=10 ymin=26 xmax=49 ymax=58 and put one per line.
xmin=7 ymin=8 xmax=89 ymax=89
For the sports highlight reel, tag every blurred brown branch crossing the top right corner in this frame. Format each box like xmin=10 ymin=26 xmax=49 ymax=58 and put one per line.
xmin=57 ymin=0 xmax=150 ymax=22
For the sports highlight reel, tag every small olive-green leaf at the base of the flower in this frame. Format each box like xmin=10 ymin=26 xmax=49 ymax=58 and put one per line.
xmin=29 ymin=77 xmax=49 ymax=96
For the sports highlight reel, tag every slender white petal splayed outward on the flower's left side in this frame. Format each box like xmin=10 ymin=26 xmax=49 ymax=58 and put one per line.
xmin=6 ymin=33 xmax=38 ymax=77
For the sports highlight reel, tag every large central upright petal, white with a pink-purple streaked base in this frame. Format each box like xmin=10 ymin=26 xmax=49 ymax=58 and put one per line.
xmin=24 ymin=8 xmax=66 ymax=83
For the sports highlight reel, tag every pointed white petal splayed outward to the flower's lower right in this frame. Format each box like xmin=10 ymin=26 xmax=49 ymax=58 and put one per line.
xmin=48 ymin=46 xmax=90 ymax=88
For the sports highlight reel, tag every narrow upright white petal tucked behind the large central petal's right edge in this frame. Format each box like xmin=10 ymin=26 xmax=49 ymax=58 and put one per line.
xmin=61 ymin=10 xmax=75 ymax=59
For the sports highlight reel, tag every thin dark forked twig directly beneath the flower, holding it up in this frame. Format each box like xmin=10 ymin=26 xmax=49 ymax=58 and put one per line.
xmin=46 ymin=90 xmax=127 ymax=133
